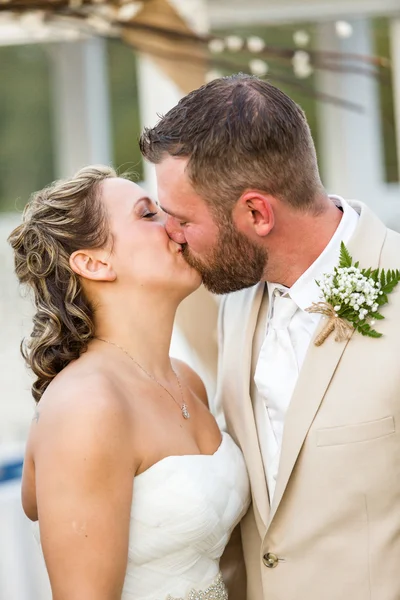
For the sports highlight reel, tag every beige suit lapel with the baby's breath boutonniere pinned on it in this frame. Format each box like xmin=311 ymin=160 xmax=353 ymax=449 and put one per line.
xmin=269 ymin=203 xmax=386 ymax=523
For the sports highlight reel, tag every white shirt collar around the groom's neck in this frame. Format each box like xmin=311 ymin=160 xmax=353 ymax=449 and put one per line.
xmin=267 ymin=195 xmax=359 ymax=310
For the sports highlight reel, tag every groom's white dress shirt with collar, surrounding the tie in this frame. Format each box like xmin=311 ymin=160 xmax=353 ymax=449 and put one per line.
xmin=253 ymin=196 xmax=359 ymax=501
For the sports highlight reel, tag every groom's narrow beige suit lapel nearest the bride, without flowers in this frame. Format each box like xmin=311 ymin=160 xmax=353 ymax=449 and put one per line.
xmin=227 ymin=283 xmax=269 ymax=536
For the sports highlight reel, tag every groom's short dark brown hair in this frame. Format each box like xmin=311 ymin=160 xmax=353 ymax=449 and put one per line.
xmin=140 ymin=74 xmax=322 ymax=212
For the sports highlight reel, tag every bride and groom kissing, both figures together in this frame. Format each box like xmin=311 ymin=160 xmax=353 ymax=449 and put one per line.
xmin=9 ymin=75 xmax=400 ymax=600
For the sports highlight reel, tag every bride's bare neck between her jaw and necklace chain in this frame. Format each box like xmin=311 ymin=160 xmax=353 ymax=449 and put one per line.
xmin=95 ymin=294 xmax=178 ymax=377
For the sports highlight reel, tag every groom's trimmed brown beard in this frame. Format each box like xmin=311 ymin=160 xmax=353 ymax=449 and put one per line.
xmin=183 ymin=221 xmax=268 ymax=294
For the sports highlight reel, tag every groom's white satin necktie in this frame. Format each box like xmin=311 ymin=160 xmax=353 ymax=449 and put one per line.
xmin=254 ymin=289 xmax=298 ymax=450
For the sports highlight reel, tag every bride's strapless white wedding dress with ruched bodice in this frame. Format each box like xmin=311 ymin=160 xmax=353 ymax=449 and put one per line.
xmin=32 ymin=433 xmax=250 ymax=600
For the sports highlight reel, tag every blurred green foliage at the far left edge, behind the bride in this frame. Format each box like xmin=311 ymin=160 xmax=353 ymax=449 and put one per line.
xmin=0 ymin=45 xmax=54 ymax=211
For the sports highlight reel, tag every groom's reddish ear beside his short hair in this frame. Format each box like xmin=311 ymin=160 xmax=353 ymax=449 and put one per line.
xmin=233 ymin=190 xmax=275 ymax=237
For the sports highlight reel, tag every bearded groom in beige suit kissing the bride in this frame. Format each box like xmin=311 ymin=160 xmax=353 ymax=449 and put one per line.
xmin=141 ymin=75 xmax=400 ymax=600
